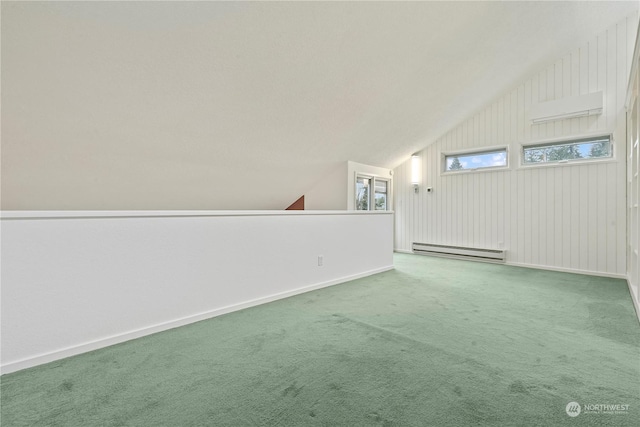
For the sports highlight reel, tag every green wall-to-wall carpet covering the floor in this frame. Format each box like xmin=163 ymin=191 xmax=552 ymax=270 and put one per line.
xmin=0 ymin=254 xmax=640 ymax=427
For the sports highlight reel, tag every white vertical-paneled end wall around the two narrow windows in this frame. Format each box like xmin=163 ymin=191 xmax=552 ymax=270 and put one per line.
xmin=394 ymin=16 xmax=638 ymax=277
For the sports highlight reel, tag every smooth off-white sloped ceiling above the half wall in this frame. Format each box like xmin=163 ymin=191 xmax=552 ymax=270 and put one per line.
xmin=2 ymin=1 xmax=638 ymax=209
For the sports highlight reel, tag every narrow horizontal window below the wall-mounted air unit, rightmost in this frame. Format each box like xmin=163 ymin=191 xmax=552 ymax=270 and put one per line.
xmin=522 ymin=135 xmax=613 ymax=165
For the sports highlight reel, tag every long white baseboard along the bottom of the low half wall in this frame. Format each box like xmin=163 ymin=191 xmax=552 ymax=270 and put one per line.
xmin=0 ymin=265 xmax=394 ymax=374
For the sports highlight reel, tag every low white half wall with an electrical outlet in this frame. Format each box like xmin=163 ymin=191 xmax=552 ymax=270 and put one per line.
xmin=1 ymin=211 xmax=393 ymax=373
